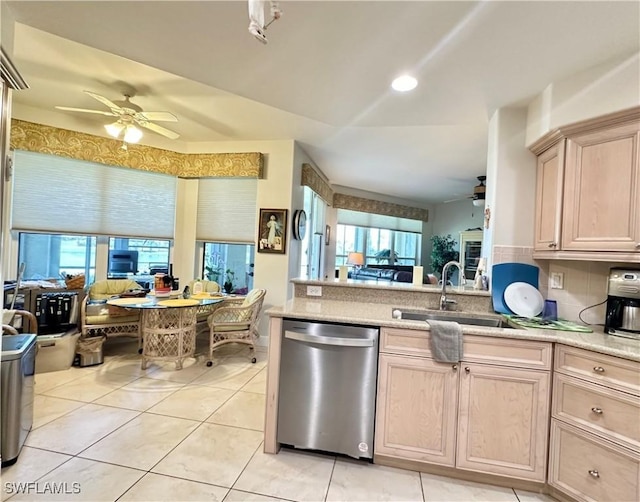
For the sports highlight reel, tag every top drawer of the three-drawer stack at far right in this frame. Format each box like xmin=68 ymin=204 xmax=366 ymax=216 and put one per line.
xmin=555 ymin=344 xmax=640 ymax=395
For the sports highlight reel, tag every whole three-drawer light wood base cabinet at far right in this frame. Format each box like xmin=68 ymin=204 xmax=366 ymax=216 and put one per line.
xmin=549 ymin=345 xmax=640 ymax=502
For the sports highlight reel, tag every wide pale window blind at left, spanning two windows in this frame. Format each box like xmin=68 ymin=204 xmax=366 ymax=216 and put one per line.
xmin=11 ymin=151 xmax=177 ymax=239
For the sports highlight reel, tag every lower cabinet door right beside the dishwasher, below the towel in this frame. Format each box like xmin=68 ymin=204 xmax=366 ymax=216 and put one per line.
xmin=375 ymin=354 xmax=458 ymax=466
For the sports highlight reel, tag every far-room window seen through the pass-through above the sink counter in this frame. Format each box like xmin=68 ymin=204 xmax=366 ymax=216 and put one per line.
xmin=336 ymin=224 xmax=422 ymax=267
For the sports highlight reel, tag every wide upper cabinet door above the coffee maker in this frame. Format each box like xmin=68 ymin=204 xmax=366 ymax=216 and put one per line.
xmin=562 ymin=124 xmax=640 ymax=251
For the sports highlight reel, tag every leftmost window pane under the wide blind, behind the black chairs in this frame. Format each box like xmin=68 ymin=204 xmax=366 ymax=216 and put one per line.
xmin=18 ymin=232 xmax=96 ymax=283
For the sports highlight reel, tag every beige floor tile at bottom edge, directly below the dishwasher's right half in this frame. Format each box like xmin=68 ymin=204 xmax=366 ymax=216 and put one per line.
xmin=327 ymin=459 xmax=423 ymax=502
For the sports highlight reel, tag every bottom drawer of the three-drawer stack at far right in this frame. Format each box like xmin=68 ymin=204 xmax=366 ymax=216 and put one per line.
xmin=549 ymin=420 xmax=640 ymax=502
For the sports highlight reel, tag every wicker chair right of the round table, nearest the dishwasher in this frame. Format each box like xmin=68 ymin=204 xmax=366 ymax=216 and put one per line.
xmin=207 ymin=289 xmax=267 ymax=366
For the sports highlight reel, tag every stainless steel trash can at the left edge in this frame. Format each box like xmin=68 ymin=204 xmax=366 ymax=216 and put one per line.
xmin=0 ymin=335 xmax=37 ymax=467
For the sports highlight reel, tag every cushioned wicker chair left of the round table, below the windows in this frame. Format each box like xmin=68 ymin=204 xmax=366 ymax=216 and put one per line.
xmin=80 ymin=279 xmax=141 ymax=339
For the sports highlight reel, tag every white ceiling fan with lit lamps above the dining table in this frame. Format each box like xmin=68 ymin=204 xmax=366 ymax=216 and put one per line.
xmin=56 ymin=91 xmax=180 ymax=144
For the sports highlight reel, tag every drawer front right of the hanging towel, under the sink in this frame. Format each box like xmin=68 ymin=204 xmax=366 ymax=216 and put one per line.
xmin=463 ymin=335 xmax=552 ymax=369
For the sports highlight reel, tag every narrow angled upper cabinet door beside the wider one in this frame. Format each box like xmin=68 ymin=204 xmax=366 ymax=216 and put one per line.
xmin=533 ymin=140 xmax=565 ymax=251
